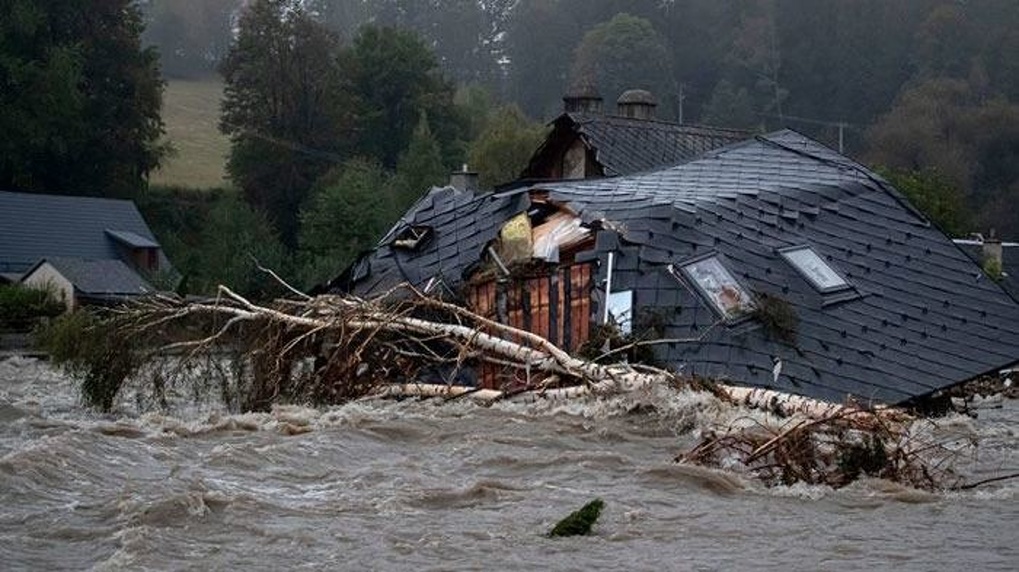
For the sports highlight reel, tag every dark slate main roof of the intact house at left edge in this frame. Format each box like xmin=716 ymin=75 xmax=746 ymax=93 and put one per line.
xmin=0 ymin=192 xmax=169 ymax=272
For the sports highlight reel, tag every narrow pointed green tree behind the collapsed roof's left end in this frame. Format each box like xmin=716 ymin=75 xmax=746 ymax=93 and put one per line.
xmin=395 ymin=112 xmax=449 ymax=206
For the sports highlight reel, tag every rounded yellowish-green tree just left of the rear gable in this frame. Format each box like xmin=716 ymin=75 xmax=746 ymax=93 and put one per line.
xmin=468 ymin=105 xmax=546 ymax=189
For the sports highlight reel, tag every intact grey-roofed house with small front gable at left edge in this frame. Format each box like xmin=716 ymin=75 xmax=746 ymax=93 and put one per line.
xmin=0 ymin=192 xmax=174 ymax=309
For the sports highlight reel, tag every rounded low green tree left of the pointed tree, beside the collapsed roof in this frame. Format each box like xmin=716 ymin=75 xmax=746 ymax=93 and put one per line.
xmin=300 ymin=158 xmax=399 ymax=287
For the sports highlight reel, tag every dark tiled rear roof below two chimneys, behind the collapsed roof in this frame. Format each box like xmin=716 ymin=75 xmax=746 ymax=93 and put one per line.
xmin=524 ymin=112 xmax=750 ymax=178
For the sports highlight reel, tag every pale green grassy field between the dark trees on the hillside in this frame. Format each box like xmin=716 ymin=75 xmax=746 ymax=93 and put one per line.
xmin=152 ymin=76 xmax=230 ymax=188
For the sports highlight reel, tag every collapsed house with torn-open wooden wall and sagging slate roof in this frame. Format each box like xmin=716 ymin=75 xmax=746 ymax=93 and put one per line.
xmin=331 ymin=131 xmax=1019 ymax=404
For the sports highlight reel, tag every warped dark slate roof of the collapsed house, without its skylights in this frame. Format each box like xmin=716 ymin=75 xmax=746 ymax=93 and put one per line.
xmin=333 ymin=131 xmax=1019 ymax=403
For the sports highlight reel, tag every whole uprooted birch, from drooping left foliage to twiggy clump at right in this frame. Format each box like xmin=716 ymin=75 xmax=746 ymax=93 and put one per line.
xmin=35 ymin=287 xmax=1006 ymax=488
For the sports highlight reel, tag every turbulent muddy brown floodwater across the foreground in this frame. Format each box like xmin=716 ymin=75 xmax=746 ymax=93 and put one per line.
xmin=0 ymin=358 xmax=1019 ymax=571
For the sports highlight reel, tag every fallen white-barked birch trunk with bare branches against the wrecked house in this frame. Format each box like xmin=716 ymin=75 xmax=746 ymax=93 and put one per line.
xmin=113 ymin=285 xmax=908 ymax=423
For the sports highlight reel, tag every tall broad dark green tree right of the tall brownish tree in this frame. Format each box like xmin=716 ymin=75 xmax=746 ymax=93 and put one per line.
xmin=341 ymin=27 xmax=466 ymax=168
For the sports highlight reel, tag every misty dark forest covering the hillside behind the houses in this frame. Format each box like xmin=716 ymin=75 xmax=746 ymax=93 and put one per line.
xmin=0 ymin=0 xmax=1019 ymax=299
